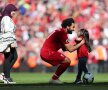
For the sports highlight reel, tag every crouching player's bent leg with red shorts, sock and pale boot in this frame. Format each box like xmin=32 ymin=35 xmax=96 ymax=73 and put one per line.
xmin=41 ymin=52 xmax=71 ymax=83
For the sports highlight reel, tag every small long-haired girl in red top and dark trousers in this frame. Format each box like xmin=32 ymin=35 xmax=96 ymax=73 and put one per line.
xmin=74 ymin=29 xmax=91 ymax=84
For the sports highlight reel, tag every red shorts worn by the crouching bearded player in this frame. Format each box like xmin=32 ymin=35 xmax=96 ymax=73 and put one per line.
xmin=41 ymin=51 xmax=66 ymax=66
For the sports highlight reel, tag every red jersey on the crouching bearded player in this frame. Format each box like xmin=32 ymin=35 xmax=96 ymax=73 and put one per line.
xmin=41 ymin=28 xmax=69 ymax=52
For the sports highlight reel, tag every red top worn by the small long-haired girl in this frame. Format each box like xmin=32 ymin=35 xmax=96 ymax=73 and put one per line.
xmin=77 ymin=36 xmax=88 ymax=58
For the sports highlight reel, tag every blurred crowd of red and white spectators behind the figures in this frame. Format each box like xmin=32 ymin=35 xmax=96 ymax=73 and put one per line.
xmin=0 ymin=0 xmax=108 ymax=73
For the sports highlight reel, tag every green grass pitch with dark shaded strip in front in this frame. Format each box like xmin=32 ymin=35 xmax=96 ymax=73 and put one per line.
xmin=0 ymin=73 xmax=108 ymax=90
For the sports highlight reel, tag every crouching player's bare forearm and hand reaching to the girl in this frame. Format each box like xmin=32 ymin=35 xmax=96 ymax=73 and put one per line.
xmin=65 ymin=40 xmax=85 ymax=52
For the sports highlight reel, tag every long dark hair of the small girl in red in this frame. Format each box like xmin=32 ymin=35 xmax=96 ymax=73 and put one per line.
xmin=80 ymin=29 xmax=92 ymax=52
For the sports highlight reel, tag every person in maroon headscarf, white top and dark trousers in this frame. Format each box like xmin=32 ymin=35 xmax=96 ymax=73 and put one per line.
xmin=0 ymin=4 xmax=17 ymax=84
